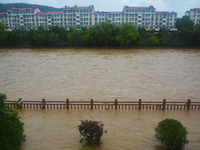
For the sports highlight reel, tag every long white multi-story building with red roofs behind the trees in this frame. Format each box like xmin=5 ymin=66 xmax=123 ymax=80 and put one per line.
xmin=0 ymin=5 xmax=177 ymax=30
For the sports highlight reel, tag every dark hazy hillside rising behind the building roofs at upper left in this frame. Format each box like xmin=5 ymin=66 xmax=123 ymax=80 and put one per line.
xmin=0 ymin=3 xmax=64 ymax=12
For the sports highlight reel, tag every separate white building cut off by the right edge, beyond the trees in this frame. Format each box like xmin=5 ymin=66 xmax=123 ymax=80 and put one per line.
xmin=185 ymin=8 xmax=200 ymax=24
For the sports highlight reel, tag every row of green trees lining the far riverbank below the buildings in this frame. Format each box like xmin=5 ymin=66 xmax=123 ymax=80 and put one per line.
xmin=0 ymin=16 xmax=200 ymax=47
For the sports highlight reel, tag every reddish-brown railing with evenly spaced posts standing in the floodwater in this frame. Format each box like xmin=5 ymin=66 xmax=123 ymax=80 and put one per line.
xmin=5 ymin=98 xmax=200 ymax=110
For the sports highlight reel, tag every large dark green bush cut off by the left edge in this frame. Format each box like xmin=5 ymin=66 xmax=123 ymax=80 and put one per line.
xmin=0 ymin=93 xmax=25 ymax=150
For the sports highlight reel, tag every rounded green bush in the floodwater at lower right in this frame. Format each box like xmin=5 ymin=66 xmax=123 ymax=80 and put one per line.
xmin=155 ymin=119 xmax=189 ymax=150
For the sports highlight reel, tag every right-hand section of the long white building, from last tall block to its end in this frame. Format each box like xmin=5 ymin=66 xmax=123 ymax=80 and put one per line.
xmin=124 ymin=6 xmax=177 ymax=30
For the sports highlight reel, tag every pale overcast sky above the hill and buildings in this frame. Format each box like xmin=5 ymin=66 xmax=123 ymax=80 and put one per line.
xmin=0 ymin=0 xmax=200 ymax=17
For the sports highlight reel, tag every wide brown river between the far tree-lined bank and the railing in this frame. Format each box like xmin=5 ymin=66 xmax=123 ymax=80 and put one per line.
xmin=0 ymin=49 xmax=200 ymax=100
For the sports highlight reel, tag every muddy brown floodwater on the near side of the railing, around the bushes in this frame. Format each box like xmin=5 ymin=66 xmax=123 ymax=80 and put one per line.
xmin=19 ymin=109 xmax=200 ymax=150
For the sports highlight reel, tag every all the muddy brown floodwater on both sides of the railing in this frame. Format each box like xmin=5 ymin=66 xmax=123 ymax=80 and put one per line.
xmin=0 ymin=49 xmax=200 ymax=150
